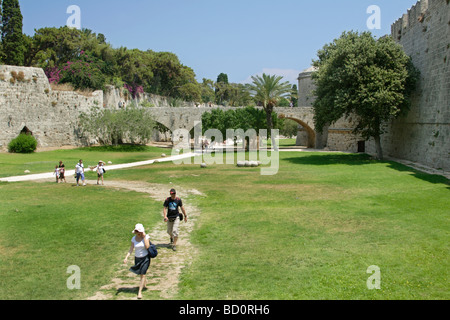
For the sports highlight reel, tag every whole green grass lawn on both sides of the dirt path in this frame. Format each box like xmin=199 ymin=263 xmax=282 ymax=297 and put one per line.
xmin=0 ymin=152 xmax=450 ymax=300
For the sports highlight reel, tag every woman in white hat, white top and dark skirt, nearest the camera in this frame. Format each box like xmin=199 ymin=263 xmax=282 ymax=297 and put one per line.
xmin=123 ymin=223 xmax=150 ymax=299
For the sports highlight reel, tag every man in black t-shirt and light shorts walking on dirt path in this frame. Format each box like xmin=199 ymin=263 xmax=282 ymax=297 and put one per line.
xmin=164 ymin=189 xmax=187 ymax=251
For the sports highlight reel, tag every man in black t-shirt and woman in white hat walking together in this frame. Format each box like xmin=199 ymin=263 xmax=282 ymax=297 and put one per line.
xmin=123 ymin=189 xmax=187 ymax=299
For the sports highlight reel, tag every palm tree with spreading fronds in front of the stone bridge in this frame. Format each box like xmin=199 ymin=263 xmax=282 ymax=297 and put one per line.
xmin=248 ymin=73 xmax=292 ymax=150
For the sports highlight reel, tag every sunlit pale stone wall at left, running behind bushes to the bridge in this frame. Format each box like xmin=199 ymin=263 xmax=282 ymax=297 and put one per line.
xmin=0 ymin=65 xmax=219 ymax=151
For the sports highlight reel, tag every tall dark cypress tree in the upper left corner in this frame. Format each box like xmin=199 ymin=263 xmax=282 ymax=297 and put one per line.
xmin=1 ymin=0 xmax=25 ymax=66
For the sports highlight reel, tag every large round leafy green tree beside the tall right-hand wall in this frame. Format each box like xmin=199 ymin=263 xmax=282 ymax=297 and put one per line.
xmin=313 ymin=32 xmax=418 ymax=159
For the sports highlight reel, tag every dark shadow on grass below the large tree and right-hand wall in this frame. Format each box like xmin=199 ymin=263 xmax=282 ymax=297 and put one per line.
xmin=283 ymin=153 xmax=450 ymax=189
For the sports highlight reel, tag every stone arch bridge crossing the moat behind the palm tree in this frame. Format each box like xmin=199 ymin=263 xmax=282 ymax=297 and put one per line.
xmin=149 ymin=106 xmax=321 ymax=148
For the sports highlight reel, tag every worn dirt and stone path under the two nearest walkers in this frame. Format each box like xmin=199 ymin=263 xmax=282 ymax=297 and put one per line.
xmin=87 ymin=181 xmax=203 ymax=300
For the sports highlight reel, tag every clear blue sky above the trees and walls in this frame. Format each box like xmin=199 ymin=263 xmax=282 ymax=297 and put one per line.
xmin=19 ymin=0 xmax=417 ymax=83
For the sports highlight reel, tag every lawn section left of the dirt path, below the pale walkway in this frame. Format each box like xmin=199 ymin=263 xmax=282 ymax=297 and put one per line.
xmin=0 ymin=183 xmax=161 ymax=300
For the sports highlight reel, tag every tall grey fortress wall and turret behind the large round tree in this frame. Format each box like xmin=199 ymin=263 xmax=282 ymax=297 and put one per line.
xmin=298 ymin=0 xmax=450 ymax=170
